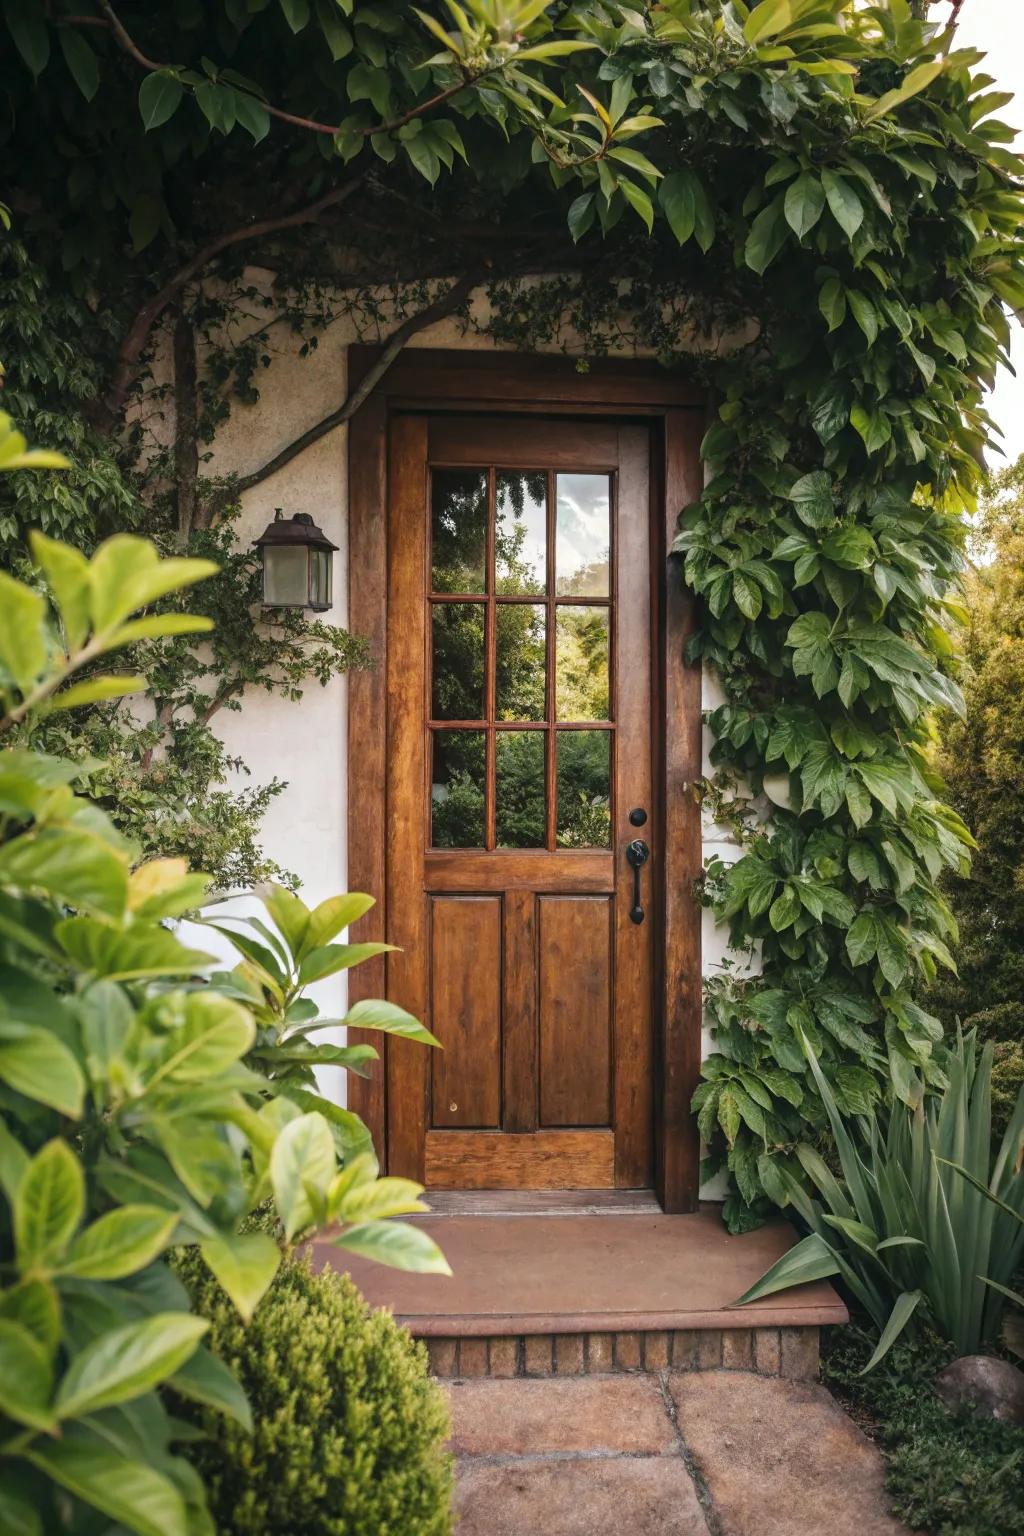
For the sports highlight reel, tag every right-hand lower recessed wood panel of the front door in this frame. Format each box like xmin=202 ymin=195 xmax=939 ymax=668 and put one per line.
xmin=537 ymin=895 xmax=611 ymax=1127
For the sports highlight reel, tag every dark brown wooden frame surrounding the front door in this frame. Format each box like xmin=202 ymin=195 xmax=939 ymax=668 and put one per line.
xmin=348 ymin=346 xmax=706 ymax=1212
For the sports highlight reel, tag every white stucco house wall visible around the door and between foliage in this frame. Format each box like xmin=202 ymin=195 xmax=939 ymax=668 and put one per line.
xmin=180 ymin=273 xmax=738 ymax=1161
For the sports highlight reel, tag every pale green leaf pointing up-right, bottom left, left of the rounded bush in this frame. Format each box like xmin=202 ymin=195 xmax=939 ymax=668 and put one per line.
xmin=55 ymin=1312 xmax=209 ymax=1419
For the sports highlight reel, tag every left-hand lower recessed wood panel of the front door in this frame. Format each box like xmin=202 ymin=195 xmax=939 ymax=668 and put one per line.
xmin=430 ymin=895 xmax=502 ymax=1127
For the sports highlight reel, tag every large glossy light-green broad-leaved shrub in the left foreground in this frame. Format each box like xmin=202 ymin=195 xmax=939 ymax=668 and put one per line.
xmin=0 ymin=531 xmax=447 ymax=1536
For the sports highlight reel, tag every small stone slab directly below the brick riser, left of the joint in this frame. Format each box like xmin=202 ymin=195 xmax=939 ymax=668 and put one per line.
xmin=450 ymin=1376 xmax=676 ymax=1456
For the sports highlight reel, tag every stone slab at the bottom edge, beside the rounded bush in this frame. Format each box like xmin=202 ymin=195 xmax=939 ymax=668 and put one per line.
xmin=456 ymin=1456 xmax=708 ymax=1536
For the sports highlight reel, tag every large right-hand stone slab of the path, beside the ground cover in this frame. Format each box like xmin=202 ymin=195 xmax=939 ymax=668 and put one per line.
xmin=668 ymin=1372 xmax=904 ymax=1536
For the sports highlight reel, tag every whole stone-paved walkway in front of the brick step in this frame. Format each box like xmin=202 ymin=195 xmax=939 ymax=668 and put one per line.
xmin=448 ymin=1370 xmax=906 ymax=1536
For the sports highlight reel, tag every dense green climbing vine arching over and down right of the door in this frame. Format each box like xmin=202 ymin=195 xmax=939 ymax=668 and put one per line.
xmin=8 ymin=0 xmax=1024 ymax=1227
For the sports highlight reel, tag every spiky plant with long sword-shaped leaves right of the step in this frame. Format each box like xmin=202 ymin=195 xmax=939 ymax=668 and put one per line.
xmin=742 ymin=1035 xmax=1024 ymax=1366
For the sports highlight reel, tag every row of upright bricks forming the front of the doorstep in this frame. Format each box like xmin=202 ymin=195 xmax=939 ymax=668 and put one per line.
xmin=424 ymin=1327 xmax=818 ymax=1381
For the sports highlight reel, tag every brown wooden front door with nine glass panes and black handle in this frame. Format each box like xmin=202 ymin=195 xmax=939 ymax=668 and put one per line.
xmin=383 ymin=413 xmax=659 ymax=1189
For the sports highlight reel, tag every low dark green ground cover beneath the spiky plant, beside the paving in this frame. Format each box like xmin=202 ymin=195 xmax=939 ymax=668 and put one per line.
xmin=821 ymin=1326 xmax=1024 ymax=1536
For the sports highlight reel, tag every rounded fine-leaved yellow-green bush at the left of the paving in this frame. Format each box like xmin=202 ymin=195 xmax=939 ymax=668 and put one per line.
xmin=178 ymin=1252 xmax=451 ymax=1536
